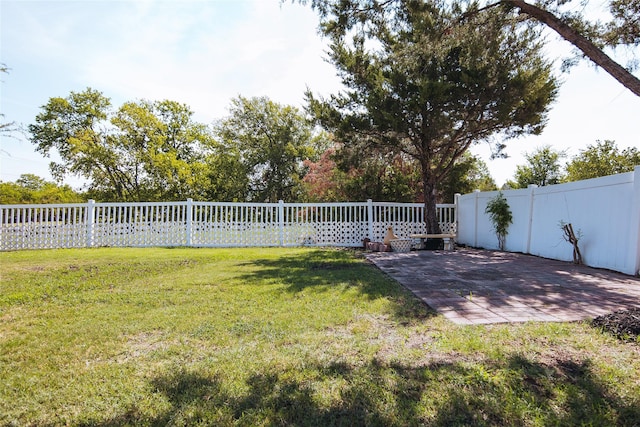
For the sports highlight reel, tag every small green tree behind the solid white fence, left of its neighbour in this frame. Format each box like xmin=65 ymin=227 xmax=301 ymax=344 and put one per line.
xmin=507 ymin=145 xmax=565 ymax=188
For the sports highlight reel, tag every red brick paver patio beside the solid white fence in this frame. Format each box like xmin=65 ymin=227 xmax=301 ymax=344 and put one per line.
xmin=367 ymin=249 xmax=640 ymax=324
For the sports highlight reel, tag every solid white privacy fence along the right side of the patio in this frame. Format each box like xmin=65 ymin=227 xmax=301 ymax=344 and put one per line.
xmin=457 ymin=166 xmax=640 ymax=275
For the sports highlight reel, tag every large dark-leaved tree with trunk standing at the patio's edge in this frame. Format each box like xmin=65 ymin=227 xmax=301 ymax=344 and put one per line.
xmin=307 ymin=1 xmax=556 ymax=233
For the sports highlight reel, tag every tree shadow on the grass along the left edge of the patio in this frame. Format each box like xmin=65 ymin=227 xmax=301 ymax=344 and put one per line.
xmin=239 ymin=249 xmax=437 ymax=322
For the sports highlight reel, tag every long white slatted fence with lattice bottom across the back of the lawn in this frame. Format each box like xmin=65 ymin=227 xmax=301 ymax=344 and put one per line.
xmin=0 ymin=199 xmax=457 ymax=250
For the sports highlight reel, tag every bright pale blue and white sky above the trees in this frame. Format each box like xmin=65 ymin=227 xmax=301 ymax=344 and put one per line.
xmin=0 ymin=0 xmax=640 ymax=192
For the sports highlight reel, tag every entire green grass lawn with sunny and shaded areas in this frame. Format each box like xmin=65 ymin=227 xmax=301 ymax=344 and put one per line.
xmin=0 ymin=248 xmax=640 ymax=426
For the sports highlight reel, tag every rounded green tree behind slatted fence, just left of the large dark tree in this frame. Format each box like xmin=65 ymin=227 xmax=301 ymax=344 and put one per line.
xmin=215 ymin=96 xmax=326 ymax=202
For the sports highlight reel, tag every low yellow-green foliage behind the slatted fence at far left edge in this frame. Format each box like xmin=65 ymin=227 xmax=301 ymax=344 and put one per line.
xmin=0 ymin=174 xmax=87 ymax=205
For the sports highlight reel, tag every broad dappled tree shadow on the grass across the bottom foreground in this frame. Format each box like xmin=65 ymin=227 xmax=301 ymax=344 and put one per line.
xmin=85 ymin=355 xmax=640 ymax=426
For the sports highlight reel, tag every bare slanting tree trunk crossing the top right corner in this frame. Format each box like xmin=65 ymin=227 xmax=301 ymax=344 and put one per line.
xmin=504 ymin=0 xmax=640 ymax=96
